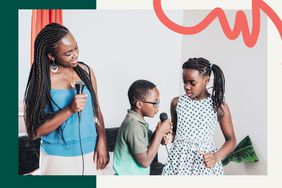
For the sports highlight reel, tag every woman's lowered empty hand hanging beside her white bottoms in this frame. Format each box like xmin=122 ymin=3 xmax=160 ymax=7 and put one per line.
xmin=94 ymin=139 xmax=110 ymax=170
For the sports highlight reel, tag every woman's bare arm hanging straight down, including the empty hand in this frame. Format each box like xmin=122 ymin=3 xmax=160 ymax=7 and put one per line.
xmin=90 ymin=68 xmax=109 ymax=169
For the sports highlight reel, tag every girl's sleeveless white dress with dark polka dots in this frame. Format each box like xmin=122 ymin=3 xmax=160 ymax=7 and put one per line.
xmin=162 ymin=95 xmax=223 ymax=175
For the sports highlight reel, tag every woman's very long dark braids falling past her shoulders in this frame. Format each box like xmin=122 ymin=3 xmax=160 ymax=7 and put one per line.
xmin=24 ymin=23 xmax=98 ymax=139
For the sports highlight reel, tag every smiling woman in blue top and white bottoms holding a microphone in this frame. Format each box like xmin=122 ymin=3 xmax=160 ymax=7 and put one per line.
xmin=24 ymin=23 xmax=109 ymax=175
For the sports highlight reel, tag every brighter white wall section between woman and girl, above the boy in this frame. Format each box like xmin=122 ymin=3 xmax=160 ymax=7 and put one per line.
xmin=64 ymin=10 xmax=182 ymax=129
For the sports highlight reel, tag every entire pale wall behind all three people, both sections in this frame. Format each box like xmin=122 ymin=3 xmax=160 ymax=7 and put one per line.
xmin=19 ymin=10 xmax=267 ymax=174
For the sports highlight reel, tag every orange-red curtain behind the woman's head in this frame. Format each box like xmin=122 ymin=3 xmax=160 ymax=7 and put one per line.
xmin=30 ymin=9 xmax=63 ymax=64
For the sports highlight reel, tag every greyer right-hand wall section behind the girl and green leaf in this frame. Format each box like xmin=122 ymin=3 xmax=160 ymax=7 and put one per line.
xmin=181 ymin=10 xmax=267 ymax=174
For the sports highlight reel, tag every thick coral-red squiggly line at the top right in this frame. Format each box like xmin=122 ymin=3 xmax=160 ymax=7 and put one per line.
xmin=153 ymin=0 xmax=282 ymax=47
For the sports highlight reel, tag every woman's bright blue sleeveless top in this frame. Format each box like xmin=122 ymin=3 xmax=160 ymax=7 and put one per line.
xmin=41 ymin=87 xmax=97 ymax=156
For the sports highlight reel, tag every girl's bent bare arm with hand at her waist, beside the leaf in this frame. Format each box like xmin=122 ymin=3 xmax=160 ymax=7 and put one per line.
xmin=203 ymin=103 xmax=236 ymax=167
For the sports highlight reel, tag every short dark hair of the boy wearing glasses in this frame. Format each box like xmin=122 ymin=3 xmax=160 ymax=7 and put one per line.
xmin=127 ymin=80 xmax=156 ymax=107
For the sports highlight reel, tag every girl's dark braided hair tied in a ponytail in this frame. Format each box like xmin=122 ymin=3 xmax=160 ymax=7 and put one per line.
xmin=182 ymin=57 xmax=225 ymax=112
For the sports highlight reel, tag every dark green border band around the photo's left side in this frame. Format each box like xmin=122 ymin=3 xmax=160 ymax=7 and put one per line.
xmin=0 ymin=0 xmax=96 ymax=188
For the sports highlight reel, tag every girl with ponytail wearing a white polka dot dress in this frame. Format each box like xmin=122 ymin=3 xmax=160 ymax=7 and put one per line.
xmin=162 ymin=58 xmax=236 ymax=175
